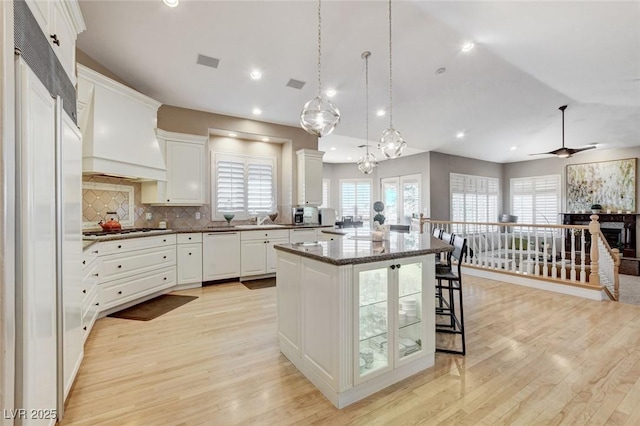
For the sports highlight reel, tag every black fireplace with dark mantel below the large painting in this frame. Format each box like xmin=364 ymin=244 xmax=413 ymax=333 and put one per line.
xmin=561 ymin=213 xmax=638 ymax=257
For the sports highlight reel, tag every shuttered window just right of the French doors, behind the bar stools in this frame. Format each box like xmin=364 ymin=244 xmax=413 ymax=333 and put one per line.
xmin=449 ymin=173 xmax=500 ymax=232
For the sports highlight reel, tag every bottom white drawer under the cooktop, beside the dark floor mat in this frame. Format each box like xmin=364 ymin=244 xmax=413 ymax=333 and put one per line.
xmin=98 ymin=265 xmax=176 ymax=310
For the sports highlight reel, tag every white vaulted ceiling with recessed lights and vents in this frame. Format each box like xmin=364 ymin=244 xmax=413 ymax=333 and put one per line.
xmin=78 ymin=0 xmax=640 ymax=162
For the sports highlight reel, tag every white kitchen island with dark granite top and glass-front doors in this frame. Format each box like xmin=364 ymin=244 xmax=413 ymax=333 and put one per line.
xmin=275 ymin=231 xmax=452 ymax=408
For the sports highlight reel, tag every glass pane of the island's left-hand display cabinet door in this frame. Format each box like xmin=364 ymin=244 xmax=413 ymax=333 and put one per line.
xmin=354 ymin=262 xmax=391 ymax=384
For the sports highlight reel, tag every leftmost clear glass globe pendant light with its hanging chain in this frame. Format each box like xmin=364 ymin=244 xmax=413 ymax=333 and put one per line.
xmin=300 ymin=0 xmax=340 ymax=138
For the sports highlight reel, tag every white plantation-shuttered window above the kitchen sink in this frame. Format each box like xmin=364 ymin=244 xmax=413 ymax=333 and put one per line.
xmin=211 ymin=153 xmax=276 ymax=219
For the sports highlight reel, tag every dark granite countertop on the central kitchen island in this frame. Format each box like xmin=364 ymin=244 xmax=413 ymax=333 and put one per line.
xmin=275 ymin=230 xmax=453 ymax=266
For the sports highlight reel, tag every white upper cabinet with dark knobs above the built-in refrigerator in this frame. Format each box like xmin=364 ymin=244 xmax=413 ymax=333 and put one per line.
xmin=26 ymin=0 xmax=86 ymax=85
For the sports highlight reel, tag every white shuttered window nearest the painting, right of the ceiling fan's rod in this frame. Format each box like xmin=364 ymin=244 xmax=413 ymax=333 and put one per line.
xmin=510 ymin=175 xmax=561 ymax=231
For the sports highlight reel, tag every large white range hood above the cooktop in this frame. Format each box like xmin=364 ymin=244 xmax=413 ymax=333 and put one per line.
xmin=78 ymin=64 xmax=167 ymax=181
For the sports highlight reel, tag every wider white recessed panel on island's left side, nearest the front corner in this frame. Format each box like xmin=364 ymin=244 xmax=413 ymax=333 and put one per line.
xmin=300 ymin=259 xmax=339 ymax=389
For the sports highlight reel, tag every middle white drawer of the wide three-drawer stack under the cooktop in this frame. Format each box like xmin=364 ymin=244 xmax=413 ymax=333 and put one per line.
xmin=98 ymin=246 xmax=176 ymax=283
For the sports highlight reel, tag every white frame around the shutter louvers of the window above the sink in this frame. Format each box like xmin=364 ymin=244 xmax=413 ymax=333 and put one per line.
xmin=209 ymin=152 xmax=278 ymax=220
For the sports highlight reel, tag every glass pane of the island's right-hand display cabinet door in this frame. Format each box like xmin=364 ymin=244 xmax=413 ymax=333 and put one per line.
xmin=397 ymin=262 xmax=424 ymax=360
